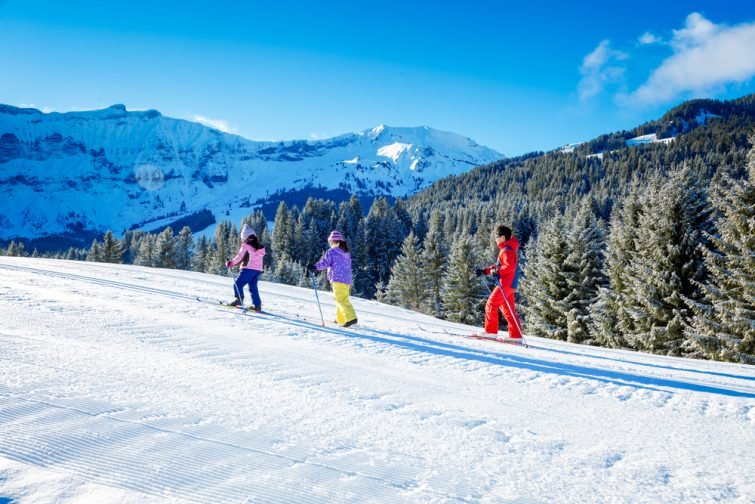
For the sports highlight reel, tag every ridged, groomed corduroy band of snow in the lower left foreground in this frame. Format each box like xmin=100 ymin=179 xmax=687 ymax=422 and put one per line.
xmin=0 ymin=393 xmax=459 ymax=503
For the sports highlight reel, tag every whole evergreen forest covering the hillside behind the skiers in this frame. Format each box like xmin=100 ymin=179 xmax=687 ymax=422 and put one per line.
xmin=2 ymin=96 xmax=755 ymax=364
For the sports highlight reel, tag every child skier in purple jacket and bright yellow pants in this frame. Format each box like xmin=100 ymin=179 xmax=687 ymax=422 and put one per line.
xmin=307 ymin=231 xmax=357 ymax=327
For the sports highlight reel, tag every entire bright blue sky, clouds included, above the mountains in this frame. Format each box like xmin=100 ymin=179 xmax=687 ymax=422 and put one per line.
xmin=0 ymin=0 xmax=755 ymax=155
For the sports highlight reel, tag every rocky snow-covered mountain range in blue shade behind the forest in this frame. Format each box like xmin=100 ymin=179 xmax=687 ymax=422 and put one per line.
xmin=0 ymin=105 xmax=503 ymax=239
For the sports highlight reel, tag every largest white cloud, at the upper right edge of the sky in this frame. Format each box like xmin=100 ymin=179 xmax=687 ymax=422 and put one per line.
xmin=625 ymin=13 xmax=755 ymax=105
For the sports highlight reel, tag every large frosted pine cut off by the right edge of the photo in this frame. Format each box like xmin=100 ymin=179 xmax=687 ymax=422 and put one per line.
xmin=687 ymin=142 xmax=755 ymax=364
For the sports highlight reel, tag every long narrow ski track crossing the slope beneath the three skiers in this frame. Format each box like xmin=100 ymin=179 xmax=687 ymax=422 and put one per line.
xmin=0 ymin=264 xmax=755 ymax=397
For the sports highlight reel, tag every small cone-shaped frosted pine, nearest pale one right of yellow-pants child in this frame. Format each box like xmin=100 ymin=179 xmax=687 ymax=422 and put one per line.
xmin=386 ymin=231 xmax=428 ymax=311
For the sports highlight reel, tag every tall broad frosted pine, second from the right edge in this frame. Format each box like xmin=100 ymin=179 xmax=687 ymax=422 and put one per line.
xmin=627 ymin=169 xmax=710 ymax=355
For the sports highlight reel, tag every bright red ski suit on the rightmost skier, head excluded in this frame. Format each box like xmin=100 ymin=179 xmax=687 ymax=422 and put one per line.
xmin=485 ymin=236 xmax=522 ymax=338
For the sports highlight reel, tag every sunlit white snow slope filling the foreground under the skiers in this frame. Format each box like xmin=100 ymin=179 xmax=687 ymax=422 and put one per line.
xmin=0 ymin=257 xmax=755 ymax=503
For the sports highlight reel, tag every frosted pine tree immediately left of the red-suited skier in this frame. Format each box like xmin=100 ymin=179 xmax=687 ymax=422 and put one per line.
xmin=443 ymin=236 xmax=484 ymax=324
